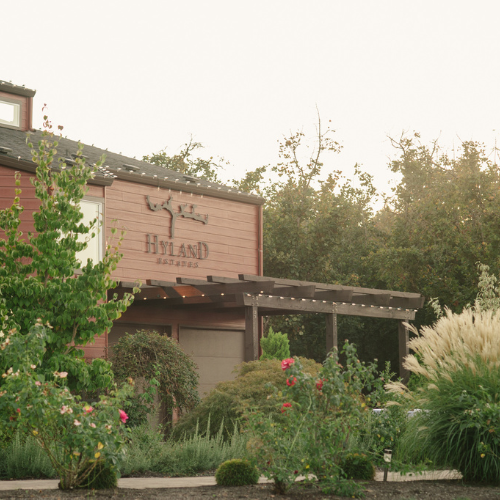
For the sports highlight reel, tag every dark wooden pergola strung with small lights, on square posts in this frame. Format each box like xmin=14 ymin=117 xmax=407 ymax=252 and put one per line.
xmin=110 ymin=274 xmax=424 ymax=377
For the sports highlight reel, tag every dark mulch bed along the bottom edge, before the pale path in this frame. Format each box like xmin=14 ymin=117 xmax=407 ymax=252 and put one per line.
xmin=0 ymin=480 xmax=500 ymax=500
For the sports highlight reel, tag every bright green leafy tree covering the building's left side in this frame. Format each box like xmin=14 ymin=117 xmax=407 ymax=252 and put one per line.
xmin=0 ymin=117 xmax=133 ymax=390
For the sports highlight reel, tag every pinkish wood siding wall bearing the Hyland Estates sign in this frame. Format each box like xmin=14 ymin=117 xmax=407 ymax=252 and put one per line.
xmin=106 ymin=180 xmax=259 ymax=281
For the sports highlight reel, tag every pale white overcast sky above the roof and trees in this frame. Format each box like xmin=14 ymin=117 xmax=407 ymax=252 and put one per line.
xmin=0 ymin=0 xmax=500 ymax=201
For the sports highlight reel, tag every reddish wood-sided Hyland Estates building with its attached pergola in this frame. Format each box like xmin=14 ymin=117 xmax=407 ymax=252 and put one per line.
xmin=0 ymin=81 xmax=423 ymax=394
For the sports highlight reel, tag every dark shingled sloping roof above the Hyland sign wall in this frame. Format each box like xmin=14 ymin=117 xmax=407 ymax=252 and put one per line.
xmin=0 ymin=127 xmax=264 ymax=205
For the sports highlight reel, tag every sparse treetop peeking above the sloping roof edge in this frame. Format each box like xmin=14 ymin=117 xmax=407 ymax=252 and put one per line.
xmin=142 ymin=138 xmax=223 ymax=182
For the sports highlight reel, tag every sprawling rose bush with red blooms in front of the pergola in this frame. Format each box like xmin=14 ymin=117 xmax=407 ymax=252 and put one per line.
xmin=246 ymin=342 xmax=376 ymax=495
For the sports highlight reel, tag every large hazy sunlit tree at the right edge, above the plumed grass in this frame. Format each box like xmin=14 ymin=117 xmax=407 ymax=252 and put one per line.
xmin=370 ymin=134 xmax=500 ymax=312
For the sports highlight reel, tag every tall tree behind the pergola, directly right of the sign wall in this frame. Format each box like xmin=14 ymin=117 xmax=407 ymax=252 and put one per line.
xmin=263 ymin=119 xmax=376 ymax=361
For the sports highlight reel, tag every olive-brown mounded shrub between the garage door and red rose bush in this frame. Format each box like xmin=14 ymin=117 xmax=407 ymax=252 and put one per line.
xmin=173 ymin=358 xmax=321 ymax=438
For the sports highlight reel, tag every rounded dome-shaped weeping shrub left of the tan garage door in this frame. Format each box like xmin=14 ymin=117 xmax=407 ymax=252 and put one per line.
xmin=111 ymin=330 xmax=199 ymax=424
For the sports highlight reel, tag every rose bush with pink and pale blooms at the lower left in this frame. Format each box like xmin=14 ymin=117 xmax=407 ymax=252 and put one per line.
xmin=0 ymin=323 xmax=130 ymax=489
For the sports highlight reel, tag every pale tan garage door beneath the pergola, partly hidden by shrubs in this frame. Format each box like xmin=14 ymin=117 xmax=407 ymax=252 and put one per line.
xmin=179 ymin=328 xmax=244 ymax=397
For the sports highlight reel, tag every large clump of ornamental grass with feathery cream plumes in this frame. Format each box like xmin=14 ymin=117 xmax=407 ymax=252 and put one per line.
xmin=388 ymin=309 xmax=500 ymax=483
